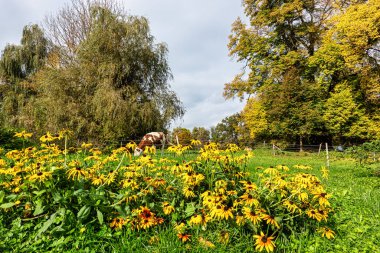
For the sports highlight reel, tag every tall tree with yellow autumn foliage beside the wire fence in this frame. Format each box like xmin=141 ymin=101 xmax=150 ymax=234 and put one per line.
xmin=229 ymin=0 xmax=380 ymax=148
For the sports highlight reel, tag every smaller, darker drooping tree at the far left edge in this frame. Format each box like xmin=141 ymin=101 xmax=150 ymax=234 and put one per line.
xmin=0 ymin=25 xmax=49 ymax=127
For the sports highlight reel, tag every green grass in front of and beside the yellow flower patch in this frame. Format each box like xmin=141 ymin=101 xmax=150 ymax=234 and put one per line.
xmin=0 ymin=146 xmax=380 ymax=253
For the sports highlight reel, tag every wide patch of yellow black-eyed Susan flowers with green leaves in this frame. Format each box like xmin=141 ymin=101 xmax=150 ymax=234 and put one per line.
xmin=0 ymin=132 xmax=335 ymax=252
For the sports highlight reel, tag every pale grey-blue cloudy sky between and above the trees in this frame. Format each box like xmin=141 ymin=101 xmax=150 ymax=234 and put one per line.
xmin=0 ymin=0 xmax=244 ymax=130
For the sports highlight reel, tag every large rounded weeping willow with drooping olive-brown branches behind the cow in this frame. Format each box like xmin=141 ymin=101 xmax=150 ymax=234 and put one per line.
xmin=0 ymin=0 xmax=184 ymax=141
